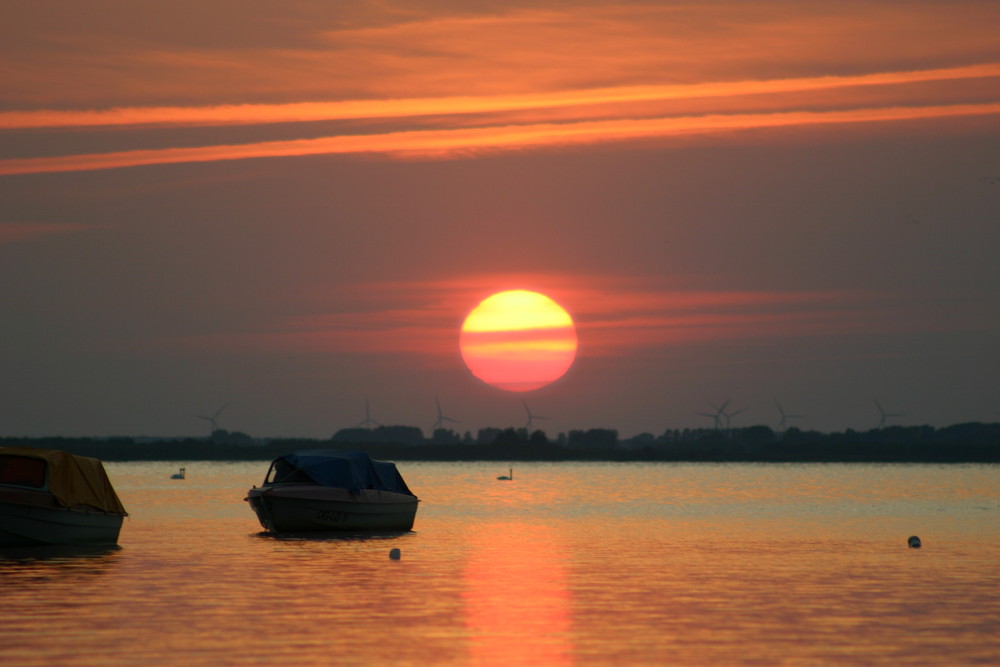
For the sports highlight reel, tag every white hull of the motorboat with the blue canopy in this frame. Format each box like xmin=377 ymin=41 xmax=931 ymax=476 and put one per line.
xmin=246 ymin=484 xmax=419 ymax=533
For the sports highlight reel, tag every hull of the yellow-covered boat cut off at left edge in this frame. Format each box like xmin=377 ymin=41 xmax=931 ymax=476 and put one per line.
xmin=0 ymin=502 xmax=124 ymax=547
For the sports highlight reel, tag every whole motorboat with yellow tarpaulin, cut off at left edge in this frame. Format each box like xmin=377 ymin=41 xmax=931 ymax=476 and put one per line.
xmin=0 ymin=447 xmax=128 ymax=547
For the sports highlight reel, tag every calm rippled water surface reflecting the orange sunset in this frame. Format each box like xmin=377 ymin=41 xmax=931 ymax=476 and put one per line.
xmin=0 ymin=462 xmax=1000 ymax=666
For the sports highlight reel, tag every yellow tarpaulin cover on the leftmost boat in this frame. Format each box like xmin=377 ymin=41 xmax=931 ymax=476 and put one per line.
xmin=0 ymin=447 xmax=127 ymax=514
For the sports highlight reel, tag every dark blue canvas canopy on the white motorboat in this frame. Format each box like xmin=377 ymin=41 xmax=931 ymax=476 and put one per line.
xmin=264 ymin=449 xmax=413 ymax=496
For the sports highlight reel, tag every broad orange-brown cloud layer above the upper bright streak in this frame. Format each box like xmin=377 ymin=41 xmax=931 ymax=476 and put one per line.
xmin=0 ymin=0 xmax=1000 ymax=109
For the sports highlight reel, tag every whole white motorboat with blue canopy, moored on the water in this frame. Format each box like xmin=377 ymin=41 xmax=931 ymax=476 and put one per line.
xmin=244 ymin=449 xmax=420 ymax=533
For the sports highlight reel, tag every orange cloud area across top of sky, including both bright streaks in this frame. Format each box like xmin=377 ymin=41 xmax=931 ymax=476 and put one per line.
xmin=0 ymin=0 xmax=1000 ymax=175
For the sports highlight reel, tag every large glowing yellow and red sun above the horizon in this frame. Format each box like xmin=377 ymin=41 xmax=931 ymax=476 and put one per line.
xmin=459 ymin=290 xmax=577 ymax=391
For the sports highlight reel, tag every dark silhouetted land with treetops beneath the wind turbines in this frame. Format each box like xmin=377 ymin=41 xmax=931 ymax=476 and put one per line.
xmin=0 ymin=422 xmax=1000 ymax=463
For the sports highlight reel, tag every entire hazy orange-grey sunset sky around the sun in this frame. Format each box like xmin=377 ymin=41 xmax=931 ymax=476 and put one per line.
xmin=0 ymin=0 xmax=1000 ymax=437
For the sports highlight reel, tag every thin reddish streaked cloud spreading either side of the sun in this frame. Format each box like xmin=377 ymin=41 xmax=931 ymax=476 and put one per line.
xmin=164 ymin=275 xmax=894 ymax=359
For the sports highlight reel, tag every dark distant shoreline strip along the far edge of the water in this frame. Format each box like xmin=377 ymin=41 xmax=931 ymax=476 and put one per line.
xmin=0 ymin=424 xmax=1000 ymax=464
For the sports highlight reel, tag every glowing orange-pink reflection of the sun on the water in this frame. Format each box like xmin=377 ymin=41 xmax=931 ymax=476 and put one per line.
xmin=462 ymin=522 xmax=573 ymax=666
